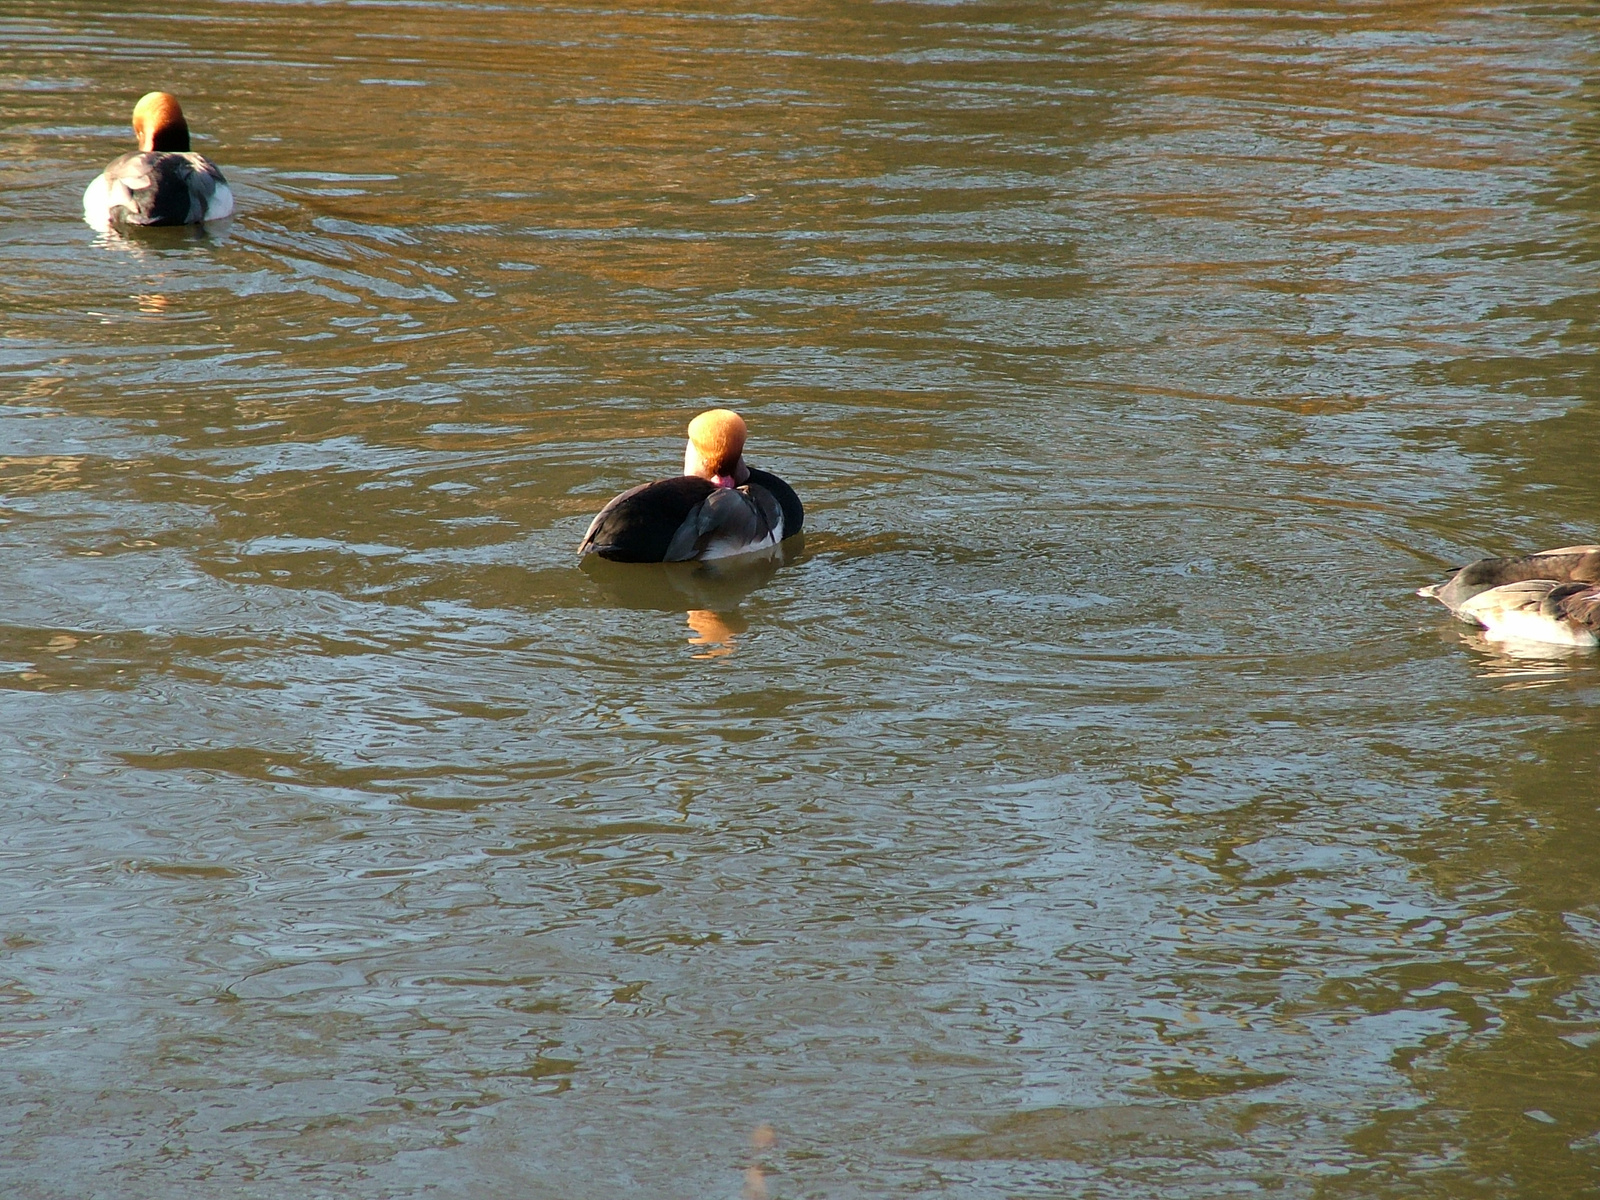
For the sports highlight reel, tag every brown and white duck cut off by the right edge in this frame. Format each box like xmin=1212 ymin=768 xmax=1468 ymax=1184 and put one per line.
xmin=1416 ymin=546 xmax=1600 ymax=646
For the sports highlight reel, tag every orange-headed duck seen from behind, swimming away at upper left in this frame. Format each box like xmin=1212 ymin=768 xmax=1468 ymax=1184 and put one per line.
xmin=83 ymin=91 xmax=234 ymax=230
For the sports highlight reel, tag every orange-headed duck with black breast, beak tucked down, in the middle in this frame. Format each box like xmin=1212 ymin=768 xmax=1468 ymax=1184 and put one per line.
xmin=578 ymin=408 xmax=805 ymax=563
